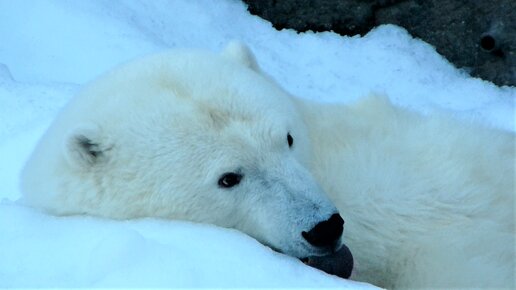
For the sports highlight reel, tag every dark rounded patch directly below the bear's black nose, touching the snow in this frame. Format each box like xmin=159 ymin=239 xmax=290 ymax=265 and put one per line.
xmin=301 ymin=244 xmax=353 ymax=279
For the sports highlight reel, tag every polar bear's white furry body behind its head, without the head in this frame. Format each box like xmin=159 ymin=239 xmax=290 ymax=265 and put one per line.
xmin=305 ymin=99 xmax=516 ymax=289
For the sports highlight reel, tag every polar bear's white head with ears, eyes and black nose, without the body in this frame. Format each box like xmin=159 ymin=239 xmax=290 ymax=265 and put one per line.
xmin=22 ymin=43 xmax=343 ymax=257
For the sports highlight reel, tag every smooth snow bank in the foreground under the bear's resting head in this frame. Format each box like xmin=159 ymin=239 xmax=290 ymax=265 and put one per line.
xmin=0 ymin=202 xmax=374 ymax=289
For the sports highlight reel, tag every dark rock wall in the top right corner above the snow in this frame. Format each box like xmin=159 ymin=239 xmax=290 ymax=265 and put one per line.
xmin=244 ymin=0 xmax=516 ymax=86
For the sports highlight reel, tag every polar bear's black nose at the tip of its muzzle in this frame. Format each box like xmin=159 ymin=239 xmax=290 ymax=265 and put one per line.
xmin=301 ymin=213 xmax=344 ymax=248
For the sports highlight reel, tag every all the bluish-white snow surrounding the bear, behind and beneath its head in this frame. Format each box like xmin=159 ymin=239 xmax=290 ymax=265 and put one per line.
xmin=0 ymin=0 xmax=516 ymax=289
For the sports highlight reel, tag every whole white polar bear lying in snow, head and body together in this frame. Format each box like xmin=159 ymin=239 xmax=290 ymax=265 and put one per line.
xmin=21 ymin=42 xmax=516 ymax=288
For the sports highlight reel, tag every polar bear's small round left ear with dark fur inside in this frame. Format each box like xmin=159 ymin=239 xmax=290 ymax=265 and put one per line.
xmin=64 ymin=125 xmax=111 ymax=168
